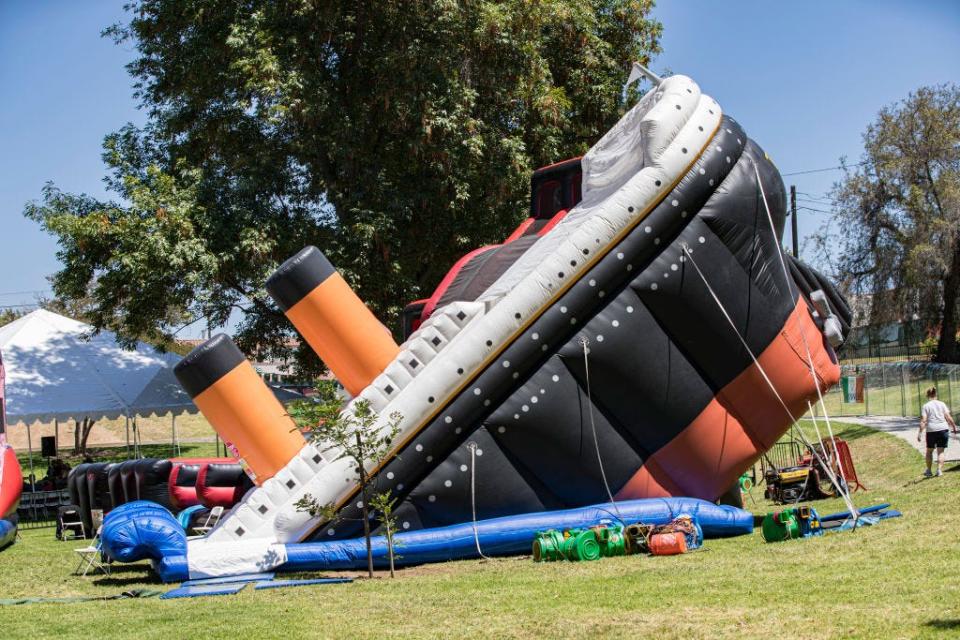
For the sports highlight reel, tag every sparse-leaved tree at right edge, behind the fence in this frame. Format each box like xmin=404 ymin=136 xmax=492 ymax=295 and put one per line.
xmin=824 ymin=85 xmax=960 ymax=362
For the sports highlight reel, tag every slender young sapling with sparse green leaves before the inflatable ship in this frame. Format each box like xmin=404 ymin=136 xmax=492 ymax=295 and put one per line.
xmin=289 ymin=400 xmax=403 ymax=578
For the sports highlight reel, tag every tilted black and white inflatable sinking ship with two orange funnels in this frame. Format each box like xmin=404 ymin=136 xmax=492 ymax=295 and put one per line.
xmin=107 ymin=71 xmax=849 ymax=576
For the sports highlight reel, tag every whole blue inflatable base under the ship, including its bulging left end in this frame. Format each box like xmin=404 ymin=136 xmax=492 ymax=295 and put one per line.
xmin=101 ymin=498 xmax=753 ymax=582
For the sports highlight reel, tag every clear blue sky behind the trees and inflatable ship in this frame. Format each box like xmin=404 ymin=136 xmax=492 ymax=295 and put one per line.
xmin=0 ymin=0 xmax=960 ymax=338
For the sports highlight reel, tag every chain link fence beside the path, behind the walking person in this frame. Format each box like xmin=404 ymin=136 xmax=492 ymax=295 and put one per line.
xmin=814 ymin=362 xmax=960 ymax=417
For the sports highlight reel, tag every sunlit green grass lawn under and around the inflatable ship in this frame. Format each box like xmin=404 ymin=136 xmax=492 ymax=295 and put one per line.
xmin=0 ymin=425 xmax=960 ymax=640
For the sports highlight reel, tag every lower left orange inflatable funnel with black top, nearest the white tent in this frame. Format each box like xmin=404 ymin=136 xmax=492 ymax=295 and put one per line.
xmin=174 ymin=334 xmax=306 ymax=484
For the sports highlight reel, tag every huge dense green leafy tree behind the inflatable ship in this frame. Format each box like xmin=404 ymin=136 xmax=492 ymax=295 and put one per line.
xmin=26 ymin=0 xmax=660 ymax=373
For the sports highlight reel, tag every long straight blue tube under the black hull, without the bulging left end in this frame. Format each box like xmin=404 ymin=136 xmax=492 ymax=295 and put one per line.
xmin=277 ymin=498 xmax=753 ymax=571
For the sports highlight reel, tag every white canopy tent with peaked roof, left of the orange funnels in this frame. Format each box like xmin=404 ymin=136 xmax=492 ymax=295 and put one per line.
xmin=0 ymin=309 xmax=300 ymax=484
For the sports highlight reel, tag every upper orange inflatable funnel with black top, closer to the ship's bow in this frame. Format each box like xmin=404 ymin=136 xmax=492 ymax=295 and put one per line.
xmin=267 ymin=246 xmax=400 ymax=395
